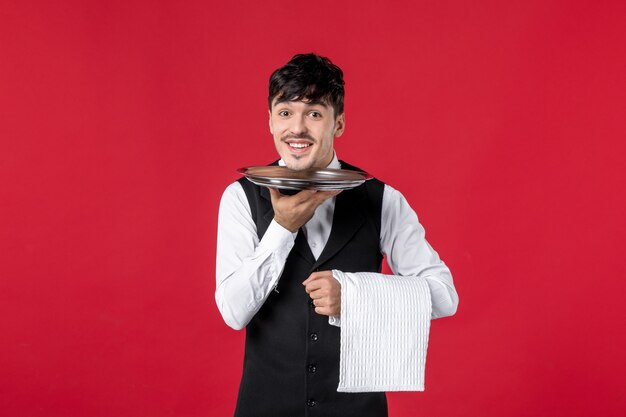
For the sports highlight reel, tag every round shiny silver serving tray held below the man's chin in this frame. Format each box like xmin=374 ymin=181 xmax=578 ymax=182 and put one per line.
xmin=237 ymin=166 xmax=372 ymax=191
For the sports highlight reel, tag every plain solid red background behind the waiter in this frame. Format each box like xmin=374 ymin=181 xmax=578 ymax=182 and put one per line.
xmin=0 ymin=0 xmax=626 ymax=417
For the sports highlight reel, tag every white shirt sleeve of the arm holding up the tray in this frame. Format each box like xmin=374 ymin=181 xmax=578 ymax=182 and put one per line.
xmin=215 ymin=182 xmax=296 ymax=330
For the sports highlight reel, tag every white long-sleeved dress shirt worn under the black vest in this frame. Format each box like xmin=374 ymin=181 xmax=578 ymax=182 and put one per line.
xmin=215 ymin=155 xmax=458 ymax=330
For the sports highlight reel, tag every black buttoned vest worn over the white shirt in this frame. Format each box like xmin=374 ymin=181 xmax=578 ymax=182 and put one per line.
xmin=235 ymin=162 xmax=387 ymax=417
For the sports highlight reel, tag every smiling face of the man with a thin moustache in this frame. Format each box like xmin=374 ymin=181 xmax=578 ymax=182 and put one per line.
xmin=269 ymin=99 xmax=345 ymax=170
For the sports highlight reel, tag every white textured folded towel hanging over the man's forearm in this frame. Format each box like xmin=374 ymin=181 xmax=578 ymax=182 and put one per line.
xmin=333 ymin=270 xmax=432 ymax=392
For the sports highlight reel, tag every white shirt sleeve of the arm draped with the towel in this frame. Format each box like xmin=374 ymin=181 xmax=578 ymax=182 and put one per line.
xmin=380 ymin=185 xmax=459 ymax=319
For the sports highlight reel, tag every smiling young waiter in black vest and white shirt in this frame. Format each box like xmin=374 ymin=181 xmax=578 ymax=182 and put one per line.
xmin=215 ymin=54 xmax=458 ymax=417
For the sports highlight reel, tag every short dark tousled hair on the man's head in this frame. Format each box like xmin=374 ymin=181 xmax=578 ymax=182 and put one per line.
xmin=268 ymin=54 xmax=344 ymax=117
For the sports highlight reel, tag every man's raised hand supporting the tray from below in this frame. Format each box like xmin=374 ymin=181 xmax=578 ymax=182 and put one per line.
xmin=269 ymin=188 xmax=341 ymax=233
